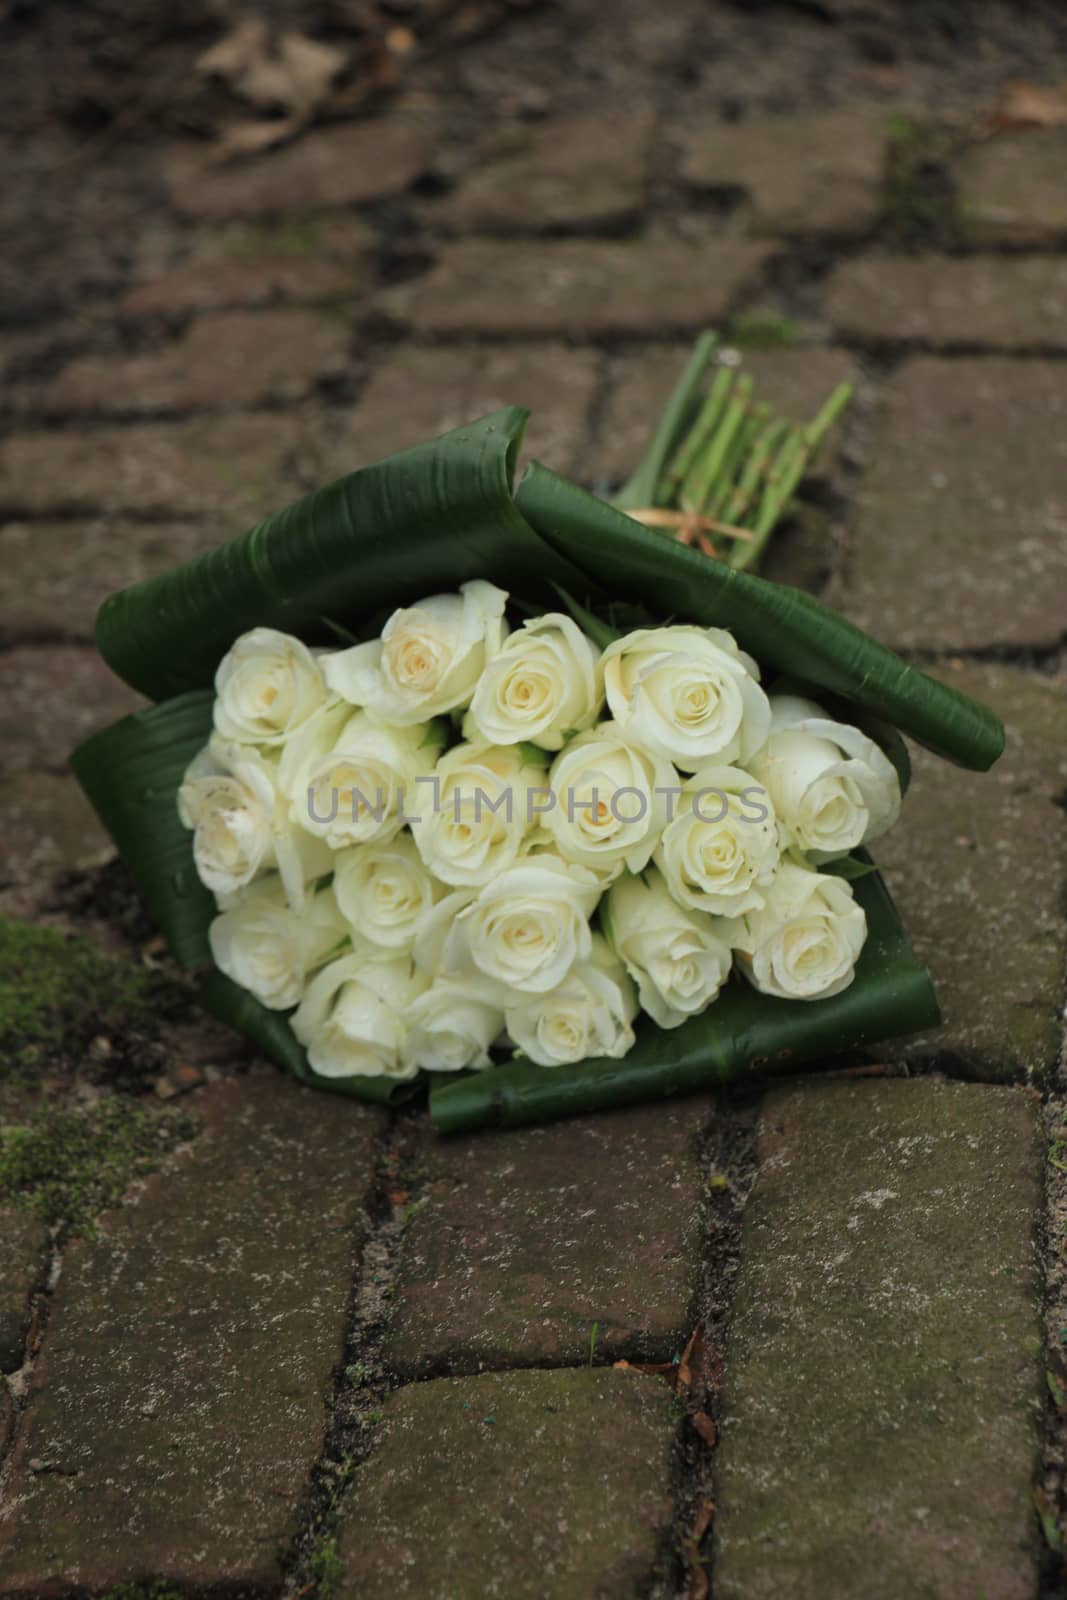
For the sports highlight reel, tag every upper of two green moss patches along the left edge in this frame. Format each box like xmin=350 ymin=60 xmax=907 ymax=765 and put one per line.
xmin=0 ymin=918 xmax=181 ymax=1075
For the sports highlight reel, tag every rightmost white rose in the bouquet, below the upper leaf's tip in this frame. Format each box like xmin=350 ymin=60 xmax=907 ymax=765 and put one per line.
xmin=750 ymin=694 xmax=901 ymax=861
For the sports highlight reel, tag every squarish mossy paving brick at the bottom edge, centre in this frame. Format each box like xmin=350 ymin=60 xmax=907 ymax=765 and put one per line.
xmin=334 ymin=1368 xmax=673 ymax=1600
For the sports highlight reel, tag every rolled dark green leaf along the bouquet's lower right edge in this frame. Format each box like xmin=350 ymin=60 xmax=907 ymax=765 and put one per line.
xmin=430 ymin=874 xmax=941 ymax=1133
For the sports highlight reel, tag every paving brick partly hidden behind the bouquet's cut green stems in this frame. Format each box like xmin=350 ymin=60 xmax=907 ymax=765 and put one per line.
xmin=584 ymin=344 xmax=857 ymax=485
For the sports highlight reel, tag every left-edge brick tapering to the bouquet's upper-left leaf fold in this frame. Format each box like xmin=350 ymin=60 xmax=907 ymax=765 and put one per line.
xmin=0 ymin=517 xmax=220 ymax=640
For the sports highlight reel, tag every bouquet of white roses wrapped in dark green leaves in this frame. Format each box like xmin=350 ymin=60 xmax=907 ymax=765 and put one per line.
xmin=74 ymin=334 xmax=1000 ymax=1130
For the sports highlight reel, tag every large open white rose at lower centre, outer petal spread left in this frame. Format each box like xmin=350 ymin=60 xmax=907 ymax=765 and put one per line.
xmin=428 ymin=856 xmax=600 ymax=994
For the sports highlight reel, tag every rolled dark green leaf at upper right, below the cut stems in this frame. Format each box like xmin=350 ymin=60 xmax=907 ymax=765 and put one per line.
xmin=515 ymin=462 xmax=1005 ymax=771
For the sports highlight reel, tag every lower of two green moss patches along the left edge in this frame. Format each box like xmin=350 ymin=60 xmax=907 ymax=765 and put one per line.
xmin=0 ymin=1098 xmax=197 ymax=1237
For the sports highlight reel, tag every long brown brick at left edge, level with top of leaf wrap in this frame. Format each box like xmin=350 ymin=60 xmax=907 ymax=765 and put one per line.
xmin=0 ymin=406 xmax=330 ymax=531
